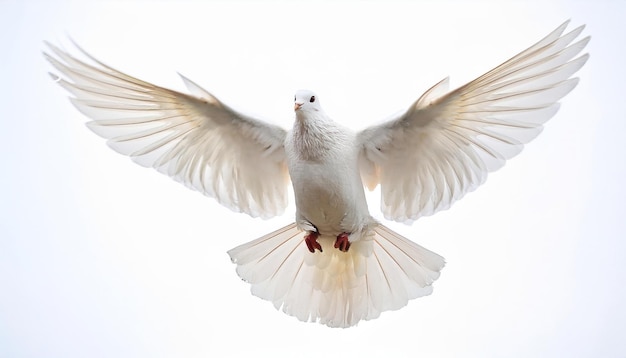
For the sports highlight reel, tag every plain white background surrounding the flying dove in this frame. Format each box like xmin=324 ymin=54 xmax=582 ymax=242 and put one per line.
xmin=0 ymin=1 xmax=626 ymax=357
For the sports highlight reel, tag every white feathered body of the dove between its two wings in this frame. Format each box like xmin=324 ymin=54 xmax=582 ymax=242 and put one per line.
xmin=285 ymin=96 xmax=375 ymax=241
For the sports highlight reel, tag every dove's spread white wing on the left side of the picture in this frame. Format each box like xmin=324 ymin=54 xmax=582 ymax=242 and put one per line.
xmin=44 ymin=44 xmax=289 ymax=218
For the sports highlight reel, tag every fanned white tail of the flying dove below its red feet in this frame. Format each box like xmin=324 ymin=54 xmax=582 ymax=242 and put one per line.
xmin=228 ymin=224 xmax=444 ymax=327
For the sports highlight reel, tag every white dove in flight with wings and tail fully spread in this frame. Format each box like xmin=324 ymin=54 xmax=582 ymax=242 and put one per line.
xmin=45 ymin=22 xmax=589 ymax=327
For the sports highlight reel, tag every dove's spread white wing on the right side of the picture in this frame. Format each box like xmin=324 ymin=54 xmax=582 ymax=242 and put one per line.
xmin=359 ymin=22 xmax=589 ymax=221
